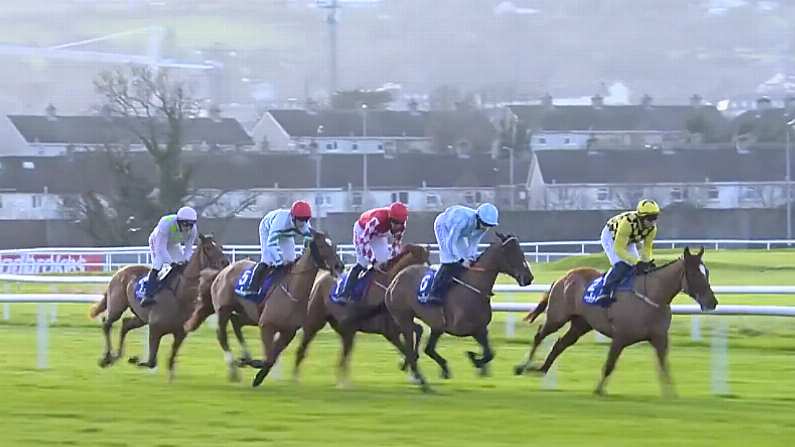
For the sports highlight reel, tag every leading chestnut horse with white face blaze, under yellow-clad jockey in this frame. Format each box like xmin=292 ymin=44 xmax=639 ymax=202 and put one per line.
xmin=515 ymin=248 xmax=718 ymax=395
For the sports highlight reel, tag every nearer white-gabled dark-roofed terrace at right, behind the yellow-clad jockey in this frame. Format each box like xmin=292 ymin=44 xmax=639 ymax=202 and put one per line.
xmin=528 ymin=145 xmax=788 ymax=210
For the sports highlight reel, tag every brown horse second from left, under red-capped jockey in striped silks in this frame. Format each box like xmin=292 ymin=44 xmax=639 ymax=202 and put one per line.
xmin=185 ymin=231 xmax=342 ymax=381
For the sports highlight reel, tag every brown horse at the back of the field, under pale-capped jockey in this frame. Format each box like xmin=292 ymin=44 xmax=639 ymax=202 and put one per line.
xmin=90 ymin=235 xmax=228 ymax=380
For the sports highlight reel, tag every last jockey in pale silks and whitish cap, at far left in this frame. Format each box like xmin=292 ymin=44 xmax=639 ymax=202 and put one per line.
xmin=141 ymin=206 xmax=198 ymax=307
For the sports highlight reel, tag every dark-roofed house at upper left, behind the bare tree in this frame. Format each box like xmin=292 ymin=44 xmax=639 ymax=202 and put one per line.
xmin=0 ymin=105 xmax=254 ymax=156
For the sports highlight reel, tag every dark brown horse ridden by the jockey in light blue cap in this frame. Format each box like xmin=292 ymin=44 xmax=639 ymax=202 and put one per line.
xmin=386 ymin=233 xmax=533 ymax=391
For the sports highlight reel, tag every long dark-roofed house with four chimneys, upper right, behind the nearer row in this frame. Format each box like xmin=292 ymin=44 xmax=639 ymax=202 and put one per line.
xmin=509 ymin=95 xmax=726 ymax=151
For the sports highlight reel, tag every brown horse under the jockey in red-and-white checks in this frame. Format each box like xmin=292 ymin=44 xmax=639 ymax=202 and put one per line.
xmin=293 ymin=244 xmax=430 ymax=386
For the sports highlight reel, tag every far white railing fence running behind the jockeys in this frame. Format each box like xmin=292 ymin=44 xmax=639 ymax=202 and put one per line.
xmin=0 ymin=239 xmax=795 ymax=273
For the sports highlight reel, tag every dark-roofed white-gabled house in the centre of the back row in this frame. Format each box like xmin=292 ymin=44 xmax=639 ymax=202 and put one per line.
xmin=252 ymin=108 xmax=496 ymax=156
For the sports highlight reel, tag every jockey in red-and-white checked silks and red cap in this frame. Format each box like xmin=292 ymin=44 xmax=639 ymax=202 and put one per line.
xmin=340 ymin=202 xmax=409 ymax=298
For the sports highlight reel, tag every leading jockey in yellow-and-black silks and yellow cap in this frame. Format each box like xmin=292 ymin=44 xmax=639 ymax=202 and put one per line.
xmin=600 ymin=200 xmax=660 ymax=298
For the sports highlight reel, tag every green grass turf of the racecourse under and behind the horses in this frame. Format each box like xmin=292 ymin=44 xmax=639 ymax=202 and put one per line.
xmin=0 ymin=252 xmax=795 ymax=446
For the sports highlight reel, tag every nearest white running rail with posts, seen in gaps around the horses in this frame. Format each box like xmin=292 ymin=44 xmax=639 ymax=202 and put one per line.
xmin=0 ymin=294 xmax=795 ymax=395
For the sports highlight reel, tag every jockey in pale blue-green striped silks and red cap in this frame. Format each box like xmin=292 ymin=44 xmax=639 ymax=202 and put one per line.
xmin=247 ymin=200 xmax=312 ymax=293
